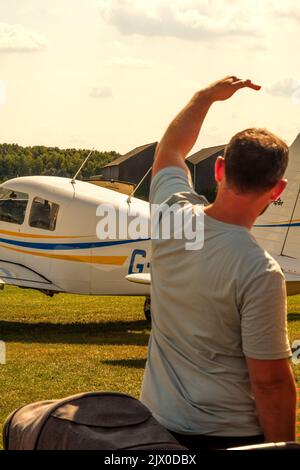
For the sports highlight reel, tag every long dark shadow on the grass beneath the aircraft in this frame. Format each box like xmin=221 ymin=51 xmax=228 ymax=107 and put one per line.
xmin=0 ymin=320 xmax=149 ymax=346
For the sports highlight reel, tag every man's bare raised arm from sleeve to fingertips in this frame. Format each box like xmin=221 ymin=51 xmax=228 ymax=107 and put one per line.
xmin=152 ymin=76 xmax=261 ymax=176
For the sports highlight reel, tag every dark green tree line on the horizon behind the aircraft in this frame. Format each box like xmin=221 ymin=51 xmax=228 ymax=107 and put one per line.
xmin=0 ymin=143 xmax=120 ymax=182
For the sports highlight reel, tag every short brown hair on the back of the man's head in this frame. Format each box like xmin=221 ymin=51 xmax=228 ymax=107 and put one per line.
xmin=224 ymin=128 xmax=289 ymax=193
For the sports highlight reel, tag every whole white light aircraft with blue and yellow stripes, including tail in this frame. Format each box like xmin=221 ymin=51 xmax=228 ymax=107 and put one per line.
xmin=0 ymin=135 xmax=300 ymax=319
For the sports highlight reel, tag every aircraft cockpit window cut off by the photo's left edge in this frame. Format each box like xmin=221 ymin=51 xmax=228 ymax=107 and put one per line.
xmin=0 ymin=188 xmax=28 ymax=225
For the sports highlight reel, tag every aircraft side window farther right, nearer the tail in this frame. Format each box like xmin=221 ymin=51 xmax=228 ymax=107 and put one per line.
xmin=29 ymin=197 xmax=59 ymax=230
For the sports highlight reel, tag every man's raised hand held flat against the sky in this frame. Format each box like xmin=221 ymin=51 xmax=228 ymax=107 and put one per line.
xmin=203 ymin=76 xmax=261 ymax=102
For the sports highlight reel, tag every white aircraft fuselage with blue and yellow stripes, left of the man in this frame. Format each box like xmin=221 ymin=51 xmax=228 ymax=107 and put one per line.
xmin=0 ymin=176 xmax=150 ymax=295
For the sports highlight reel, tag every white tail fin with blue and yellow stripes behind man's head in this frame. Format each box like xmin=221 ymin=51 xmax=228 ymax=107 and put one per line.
xmin=252 ymin=134 xmax=300 ymax=259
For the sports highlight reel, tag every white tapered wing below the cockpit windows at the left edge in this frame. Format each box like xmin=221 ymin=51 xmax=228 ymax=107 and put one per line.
xmin=0 ymin=260 xmax=60 ymax=291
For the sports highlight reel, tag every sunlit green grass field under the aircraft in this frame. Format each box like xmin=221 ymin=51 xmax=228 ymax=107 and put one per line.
xmin=0 ymin=287 xmax=300 ymax=446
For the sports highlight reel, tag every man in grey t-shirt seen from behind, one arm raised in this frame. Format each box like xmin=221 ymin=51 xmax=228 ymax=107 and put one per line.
xmin=141 ymin=77 xmax=296 ymax=449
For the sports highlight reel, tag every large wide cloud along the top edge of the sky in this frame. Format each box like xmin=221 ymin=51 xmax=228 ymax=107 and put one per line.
xmin=99 ymin=0 xmax=259 ymax=41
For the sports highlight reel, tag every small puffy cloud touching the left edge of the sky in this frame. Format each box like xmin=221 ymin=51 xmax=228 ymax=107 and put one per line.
xmin=0 ymin=23 xmax=47 ymax=53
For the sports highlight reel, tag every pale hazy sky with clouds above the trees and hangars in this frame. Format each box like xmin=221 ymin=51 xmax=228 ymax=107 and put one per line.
xmin=0 ymin=0 xmax=300 ymax=153
